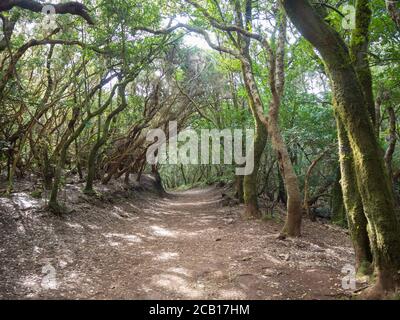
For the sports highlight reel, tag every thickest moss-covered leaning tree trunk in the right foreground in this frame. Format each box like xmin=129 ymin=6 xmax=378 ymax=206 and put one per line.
xmin=282 ymin=0 xmax=400 ymax=294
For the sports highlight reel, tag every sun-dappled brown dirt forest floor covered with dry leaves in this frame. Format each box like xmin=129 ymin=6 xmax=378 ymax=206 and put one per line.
xmin=0 ymin=178 xmax=354 ymax=299
